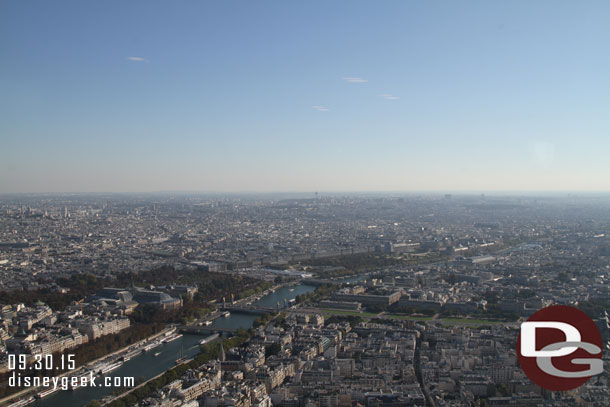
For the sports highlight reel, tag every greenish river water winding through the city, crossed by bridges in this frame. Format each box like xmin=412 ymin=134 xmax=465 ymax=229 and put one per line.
xmin=33 ymin=285 xmax=315 ymax=407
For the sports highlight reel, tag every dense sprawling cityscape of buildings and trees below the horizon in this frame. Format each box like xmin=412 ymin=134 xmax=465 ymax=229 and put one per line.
xmin=0 ymin=194 xmax=610 ymax=407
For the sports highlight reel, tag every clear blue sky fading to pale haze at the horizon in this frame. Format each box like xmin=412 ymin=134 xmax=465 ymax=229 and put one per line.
xmin=0 ymin=0 xmax=610 ymax=193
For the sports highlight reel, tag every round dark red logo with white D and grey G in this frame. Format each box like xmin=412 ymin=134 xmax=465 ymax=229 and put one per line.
xmin=517 ymin=305 xmax=604 ymax=391
